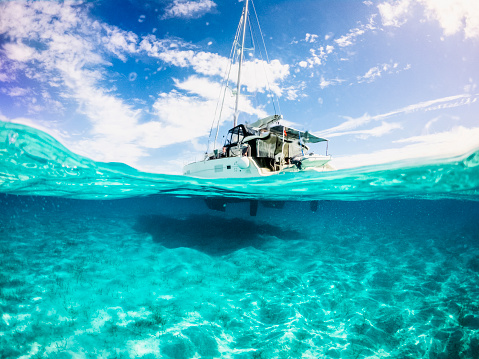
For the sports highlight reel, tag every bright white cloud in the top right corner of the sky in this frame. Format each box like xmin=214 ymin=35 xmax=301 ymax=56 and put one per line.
xmin=378 ymin=0 xmax=479 ymax=39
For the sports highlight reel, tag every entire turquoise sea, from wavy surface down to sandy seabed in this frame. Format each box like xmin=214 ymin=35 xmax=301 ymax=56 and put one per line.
xmin=0 ymin=122 xmax=479 ymax=359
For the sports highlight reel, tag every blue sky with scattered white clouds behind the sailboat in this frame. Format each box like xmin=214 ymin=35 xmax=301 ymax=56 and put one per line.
xmin=0 ymin=0 xmax=479 ymax=174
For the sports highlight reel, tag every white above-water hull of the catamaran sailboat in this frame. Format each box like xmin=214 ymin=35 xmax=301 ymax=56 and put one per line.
xmin=183 ymin=155 xmax=335 ymax=179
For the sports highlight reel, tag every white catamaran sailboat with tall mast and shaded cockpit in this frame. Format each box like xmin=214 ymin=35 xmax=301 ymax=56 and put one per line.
xmin=183 ymin=0 xmax=334 ymax=179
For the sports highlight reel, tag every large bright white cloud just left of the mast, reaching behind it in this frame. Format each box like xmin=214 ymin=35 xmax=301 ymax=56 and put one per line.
xmin=66 ymin=76 xmax=267 ymax=165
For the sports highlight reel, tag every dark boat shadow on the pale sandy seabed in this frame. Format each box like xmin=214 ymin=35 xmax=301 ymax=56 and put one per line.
xmin=135 ymin=214 xmax=301 ymax=255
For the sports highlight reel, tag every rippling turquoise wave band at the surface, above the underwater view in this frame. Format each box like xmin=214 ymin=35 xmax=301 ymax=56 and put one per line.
xmin=0 ymin=121 xmax=479 ymax=201
